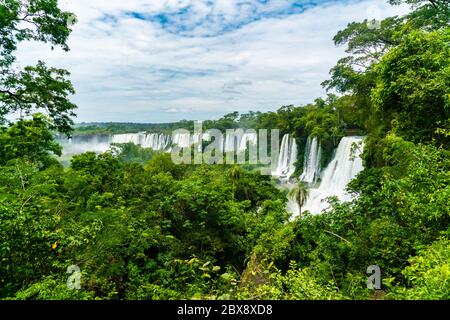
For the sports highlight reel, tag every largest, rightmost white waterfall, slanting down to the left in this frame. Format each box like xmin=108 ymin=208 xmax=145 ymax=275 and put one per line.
xmin=302 ymin=137 xmax=364 ymax=213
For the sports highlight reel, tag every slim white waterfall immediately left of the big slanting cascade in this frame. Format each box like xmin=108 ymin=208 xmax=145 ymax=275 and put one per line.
xmin=300 ymin=137 xmax=322 ymax=184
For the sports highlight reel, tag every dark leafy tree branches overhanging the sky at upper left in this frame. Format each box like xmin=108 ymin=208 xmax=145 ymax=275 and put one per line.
xmin=0 ymin=0 xmax=76 ymax=133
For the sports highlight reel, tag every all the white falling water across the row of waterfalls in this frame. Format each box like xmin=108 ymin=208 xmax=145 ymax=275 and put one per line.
xmin=58 ymin=132 xmax=363 ymax=216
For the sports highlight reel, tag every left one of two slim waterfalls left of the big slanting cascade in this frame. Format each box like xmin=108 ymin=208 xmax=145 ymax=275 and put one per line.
xmin=272 ymin=134 xmax=297 ymax=180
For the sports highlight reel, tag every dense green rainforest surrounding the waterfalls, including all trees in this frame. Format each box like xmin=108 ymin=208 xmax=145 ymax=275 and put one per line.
xmin=0 ymin=0 xmax=450 ymax=299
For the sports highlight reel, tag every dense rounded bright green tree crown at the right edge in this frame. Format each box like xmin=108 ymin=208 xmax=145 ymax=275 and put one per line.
xmin=372 ymin=28 xmax=450 ymax=145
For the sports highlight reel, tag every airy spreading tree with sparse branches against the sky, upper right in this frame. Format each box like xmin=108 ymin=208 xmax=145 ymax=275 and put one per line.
xmin=322 ymin=0 xmax=450 ymax=93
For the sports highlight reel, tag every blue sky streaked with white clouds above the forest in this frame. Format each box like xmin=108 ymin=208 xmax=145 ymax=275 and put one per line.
xmin=18 ymin=0 xmax=407 ymax=122
